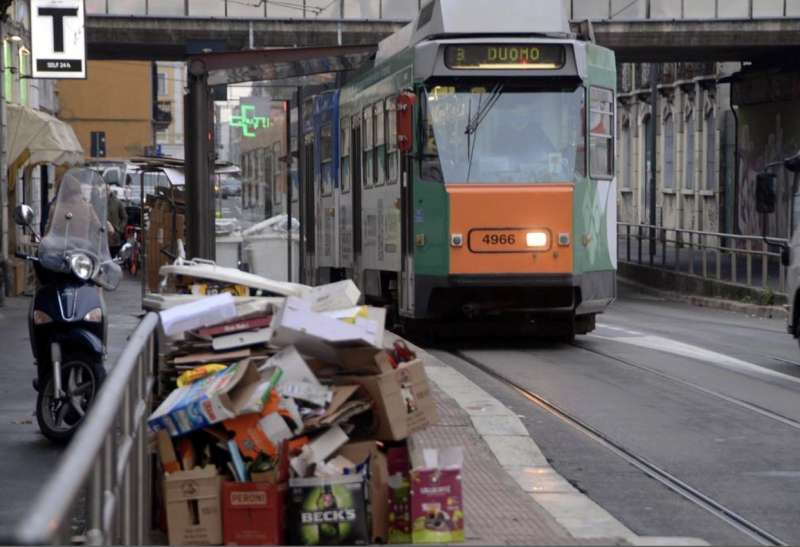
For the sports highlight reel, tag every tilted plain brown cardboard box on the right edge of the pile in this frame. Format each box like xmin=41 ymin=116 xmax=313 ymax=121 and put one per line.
xmin=337 ymin=359 xmax=438 ymax=441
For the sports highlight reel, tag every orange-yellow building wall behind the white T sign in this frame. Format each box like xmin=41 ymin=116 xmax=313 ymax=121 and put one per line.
xmin=58 ymin=61 xmax=153 ymax=159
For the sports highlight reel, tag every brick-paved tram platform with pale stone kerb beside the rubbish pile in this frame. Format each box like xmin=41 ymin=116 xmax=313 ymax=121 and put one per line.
xmin=411 ymin=340 xmax=624 ymax=545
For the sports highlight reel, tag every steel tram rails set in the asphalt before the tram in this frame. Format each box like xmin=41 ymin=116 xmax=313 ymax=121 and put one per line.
xmin=450 ymin=352 xmax=800 ymax=545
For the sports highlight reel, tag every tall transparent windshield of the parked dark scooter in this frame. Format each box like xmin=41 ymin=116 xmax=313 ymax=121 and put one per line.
xmin=38 ymin=168 xmax=122 ymax=290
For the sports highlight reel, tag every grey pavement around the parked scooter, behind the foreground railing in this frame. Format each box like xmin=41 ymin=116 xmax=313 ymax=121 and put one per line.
xmin=0 ymin=278 xmax=141 ymax=537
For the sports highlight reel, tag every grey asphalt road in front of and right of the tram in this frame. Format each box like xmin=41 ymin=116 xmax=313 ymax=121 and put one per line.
xmin=433 ymin=291 xmax=800 ymax=544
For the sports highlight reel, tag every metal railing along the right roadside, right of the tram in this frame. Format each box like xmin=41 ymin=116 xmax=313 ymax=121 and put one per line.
xmin=617 ymin=222 xmax=788 ymax=296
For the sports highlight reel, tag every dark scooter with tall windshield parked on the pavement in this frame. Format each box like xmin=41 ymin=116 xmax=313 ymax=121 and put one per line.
xmin=14 ymin=169 xmax=129 ymax=443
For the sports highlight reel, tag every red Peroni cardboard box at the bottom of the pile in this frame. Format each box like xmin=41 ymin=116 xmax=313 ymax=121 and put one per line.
xmin=222 ymin=481 xmax=287 ymax=545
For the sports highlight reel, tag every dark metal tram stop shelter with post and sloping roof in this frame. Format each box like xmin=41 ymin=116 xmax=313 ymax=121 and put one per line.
xmin=184 ymin=45 xmax=378 ymax=276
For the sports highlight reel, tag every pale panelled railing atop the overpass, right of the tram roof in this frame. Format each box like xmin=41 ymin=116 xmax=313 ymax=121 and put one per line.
xmin=568 ymin=0 xmax=798 ymax=20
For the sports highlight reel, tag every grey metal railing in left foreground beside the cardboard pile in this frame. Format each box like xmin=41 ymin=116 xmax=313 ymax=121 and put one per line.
xmin=13 ymin=313 xmax=158 ymax=545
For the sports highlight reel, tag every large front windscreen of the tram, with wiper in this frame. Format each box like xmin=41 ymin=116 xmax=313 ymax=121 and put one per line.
xmin=421 ymin=81 xmax=586 ymax=184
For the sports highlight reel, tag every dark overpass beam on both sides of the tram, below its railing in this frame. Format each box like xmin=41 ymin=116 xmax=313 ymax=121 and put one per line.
xmin=87 ymin=15 xmax=800 ymax=64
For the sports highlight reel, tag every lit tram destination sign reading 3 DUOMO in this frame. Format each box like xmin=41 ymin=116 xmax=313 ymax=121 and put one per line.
xmin=444 ymin=44 xmax=567 ymax=70
